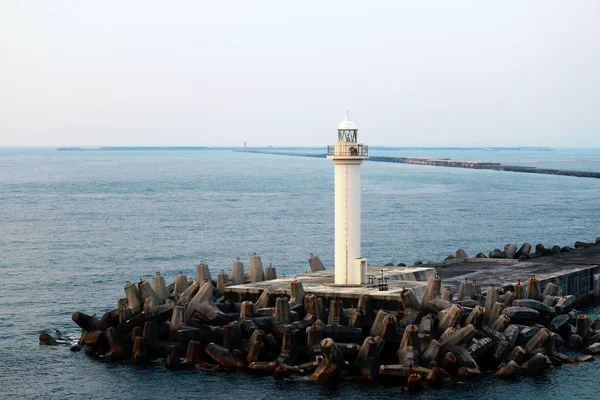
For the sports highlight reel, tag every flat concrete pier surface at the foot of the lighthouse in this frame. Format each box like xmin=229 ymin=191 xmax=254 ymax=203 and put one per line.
xmin=225 ymin=246 xmax=600 ymax=306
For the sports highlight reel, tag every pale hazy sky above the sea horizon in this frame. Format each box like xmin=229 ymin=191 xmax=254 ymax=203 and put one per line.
xmin=0 ymin=0 xmax=600 ymax=148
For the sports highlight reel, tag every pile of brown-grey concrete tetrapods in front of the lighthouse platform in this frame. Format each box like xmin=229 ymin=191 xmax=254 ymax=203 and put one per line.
xmin=64 ymin=262 xmax=600 ymax=389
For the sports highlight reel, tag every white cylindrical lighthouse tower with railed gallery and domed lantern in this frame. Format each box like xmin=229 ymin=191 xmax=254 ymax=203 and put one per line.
xmin=327 ymin=113 xmax=369 ymax=285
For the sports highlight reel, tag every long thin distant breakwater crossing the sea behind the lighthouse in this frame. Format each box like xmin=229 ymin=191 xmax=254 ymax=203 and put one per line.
xmin=239 ymin=150 xmax=600 ymax=179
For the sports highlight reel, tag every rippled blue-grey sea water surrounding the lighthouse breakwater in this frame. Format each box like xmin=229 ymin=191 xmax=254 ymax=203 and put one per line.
xmin=0 ymin=149 xmax=600 ymax=399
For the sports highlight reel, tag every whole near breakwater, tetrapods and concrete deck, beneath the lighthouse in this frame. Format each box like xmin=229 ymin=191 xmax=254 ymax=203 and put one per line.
xmin=48 ymin=238 xmax=600 ymax=389
